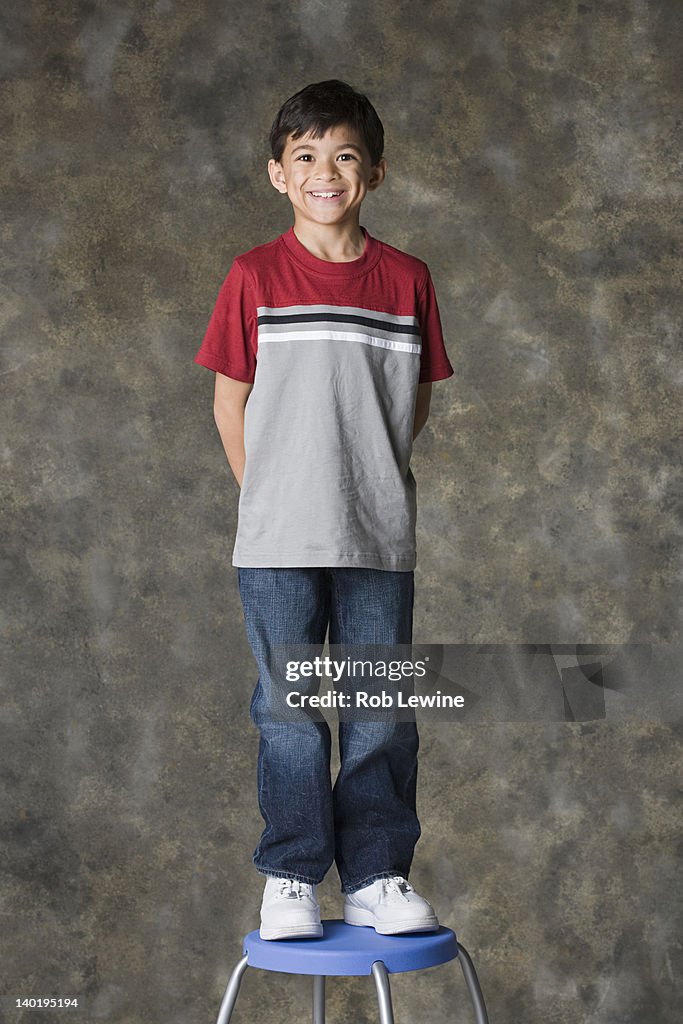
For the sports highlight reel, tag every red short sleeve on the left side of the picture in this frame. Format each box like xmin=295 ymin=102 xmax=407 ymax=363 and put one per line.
xmin=195 ymin=260 xmax=258 ymax=383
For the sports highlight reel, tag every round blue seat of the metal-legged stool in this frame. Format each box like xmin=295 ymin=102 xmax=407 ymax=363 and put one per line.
xmin=244 ymin=921 xmax=458 ymax=976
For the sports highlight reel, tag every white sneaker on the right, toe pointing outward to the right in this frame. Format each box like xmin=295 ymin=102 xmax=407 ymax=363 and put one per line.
xmin=344 ymin=874 xmax=438 ymax=935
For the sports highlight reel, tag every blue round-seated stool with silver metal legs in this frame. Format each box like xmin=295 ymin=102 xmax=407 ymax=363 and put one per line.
xmin=216 ymin=921 xmax=488 ymax=1024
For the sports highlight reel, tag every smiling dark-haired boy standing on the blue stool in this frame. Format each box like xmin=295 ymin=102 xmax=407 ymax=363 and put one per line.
xmin=195 ymin=80 xmax=453 ymax=939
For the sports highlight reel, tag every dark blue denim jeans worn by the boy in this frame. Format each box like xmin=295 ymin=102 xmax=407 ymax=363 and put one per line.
xmin=238 ymin=567 xmax=420 ymax=893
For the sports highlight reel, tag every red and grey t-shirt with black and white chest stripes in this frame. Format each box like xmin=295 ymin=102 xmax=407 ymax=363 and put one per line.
xmin=195 ymin=227 xmax=453 ymax=571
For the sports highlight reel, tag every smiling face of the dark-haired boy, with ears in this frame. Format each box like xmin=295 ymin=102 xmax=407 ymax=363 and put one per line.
xmin=268 ymin=125 xmax=386 ymax=226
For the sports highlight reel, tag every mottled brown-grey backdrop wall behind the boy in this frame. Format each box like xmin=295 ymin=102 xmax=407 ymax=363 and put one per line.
xmin=0 ymin=0 xmax=683 ymax=1024
